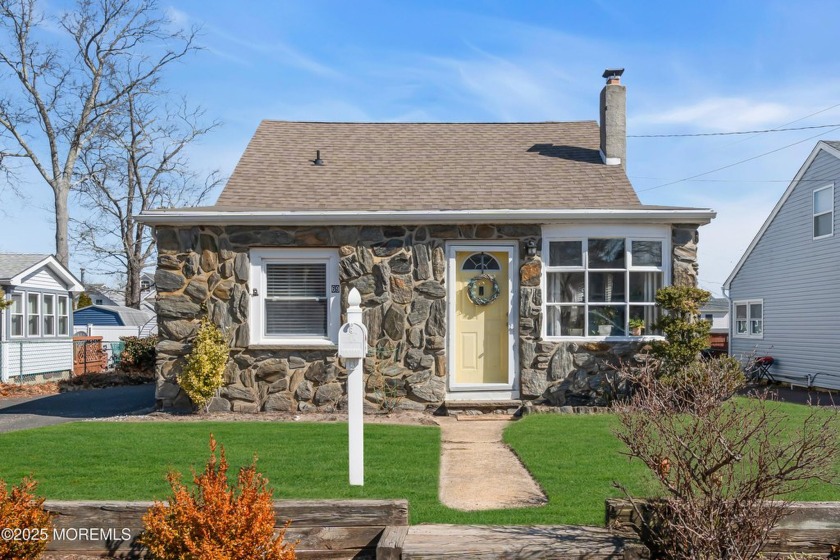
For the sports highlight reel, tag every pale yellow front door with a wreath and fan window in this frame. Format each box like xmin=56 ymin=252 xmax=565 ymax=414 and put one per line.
xmin=453 ymin=249 xmax=510 ymax=385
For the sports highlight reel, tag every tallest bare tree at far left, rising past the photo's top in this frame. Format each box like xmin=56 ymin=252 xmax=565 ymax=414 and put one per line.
xmin=0 ymin=0 xmax=195 ymax=265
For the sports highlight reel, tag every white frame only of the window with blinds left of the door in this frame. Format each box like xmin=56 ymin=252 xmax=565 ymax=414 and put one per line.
xmin=248 ymin=248 xmax=341 ymax=348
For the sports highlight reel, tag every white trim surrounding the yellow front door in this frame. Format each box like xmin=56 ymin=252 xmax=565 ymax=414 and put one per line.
xmin=446 ymin=240 xmax=519 ymax=400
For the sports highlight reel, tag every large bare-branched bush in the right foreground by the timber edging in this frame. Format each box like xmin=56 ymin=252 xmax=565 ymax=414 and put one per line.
xmin=614 ymin=358 xmax=840 ymax=560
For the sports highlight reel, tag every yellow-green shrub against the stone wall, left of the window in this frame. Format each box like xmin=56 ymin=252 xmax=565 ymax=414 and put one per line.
xmin=178 ymin=318 xmax=230 ymax=408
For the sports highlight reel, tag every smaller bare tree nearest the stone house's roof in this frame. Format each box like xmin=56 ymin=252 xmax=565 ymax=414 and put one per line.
xmin=73 ymin=92 xmax=220 ymax=307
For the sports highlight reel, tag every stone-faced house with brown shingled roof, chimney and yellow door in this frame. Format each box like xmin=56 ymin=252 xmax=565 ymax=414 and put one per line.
xmin=141 ymin=71 xmax=714 ymax=412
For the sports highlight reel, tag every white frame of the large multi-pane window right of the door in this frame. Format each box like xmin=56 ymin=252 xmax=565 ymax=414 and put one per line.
xmin=541 ymin=224 xmax=672 ymax=341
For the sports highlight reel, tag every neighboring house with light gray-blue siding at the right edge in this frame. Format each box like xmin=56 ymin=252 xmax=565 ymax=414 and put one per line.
xmin=724 ymin=141 xmax=840 ymax=389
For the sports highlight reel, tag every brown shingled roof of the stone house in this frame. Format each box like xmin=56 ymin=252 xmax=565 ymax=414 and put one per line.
xmin=214 ymin=121 xmax=642 ymax=212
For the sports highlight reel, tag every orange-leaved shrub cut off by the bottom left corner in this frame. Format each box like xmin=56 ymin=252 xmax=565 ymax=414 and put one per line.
xmin=0 ymin=478 xmax=52 ymax=560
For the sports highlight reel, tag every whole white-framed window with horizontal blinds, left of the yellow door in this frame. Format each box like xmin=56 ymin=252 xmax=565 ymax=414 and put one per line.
xmin=250 ymin=249 xmax=341 ymax=346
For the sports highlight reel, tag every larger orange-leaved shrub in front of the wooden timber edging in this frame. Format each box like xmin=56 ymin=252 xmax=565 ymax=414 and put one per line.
xmin=139 ymin=434 xmax=295 ymax=560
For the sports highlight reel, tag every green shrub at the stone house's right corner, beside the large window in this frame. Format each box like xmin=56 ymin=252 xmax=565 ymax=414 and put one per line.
xmin=653 ymin=286 xmax=712 ymax=375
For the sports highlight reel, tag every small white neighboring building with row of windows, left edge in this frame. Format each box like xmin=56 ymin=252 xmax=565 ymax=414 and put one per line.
xmin=0 ymin=253 xmax=82 ymax=382
